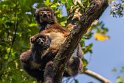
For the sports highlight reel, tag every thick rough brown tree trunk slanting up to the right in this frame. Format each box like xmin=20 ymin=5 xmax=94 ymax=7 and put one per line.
xmin=44 ymin=0 xmax=108 ymax=83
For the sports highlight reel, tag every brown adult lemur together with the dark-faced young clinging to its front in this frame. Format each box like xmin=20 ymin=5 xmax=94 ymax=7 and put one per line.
xmin=20 ymin=7 xmax=82 ymax=82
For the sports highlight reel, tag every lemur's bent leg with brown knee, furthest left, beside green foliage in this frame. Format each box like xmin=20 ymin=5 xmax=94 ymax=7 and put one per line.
xmin=20 ymin=50 xmax=44 ymax=81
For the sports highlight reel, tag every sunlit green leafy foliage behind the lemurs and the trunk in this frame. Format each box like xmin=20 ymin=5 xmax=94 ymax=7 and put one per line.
xmin=0 ymin=0 xmax=123 ymax=83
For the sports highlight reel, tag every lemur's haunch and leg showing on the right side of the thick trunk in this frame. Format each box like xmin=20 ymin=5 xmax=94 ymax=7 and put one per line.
xmin=64 ymin=45 xmax=83 ymax=77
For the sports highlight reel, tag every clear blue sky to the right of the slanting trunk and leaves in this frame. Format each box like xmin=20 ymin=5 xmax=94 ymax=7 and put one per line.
xmin=71 ymin=8 xmax=124 ymax=83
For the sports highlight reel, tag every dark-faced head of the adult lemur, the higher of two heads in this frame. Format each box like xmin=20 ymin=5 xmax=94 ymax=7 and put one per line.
xmin=35 ymin=7 xmax=56 ymax=25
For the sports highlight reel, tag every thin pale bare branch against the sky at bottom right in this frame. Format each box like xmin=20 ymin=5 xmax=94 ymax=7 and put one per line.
xmin=82 ymin=70 xmax=111 ymax=83
